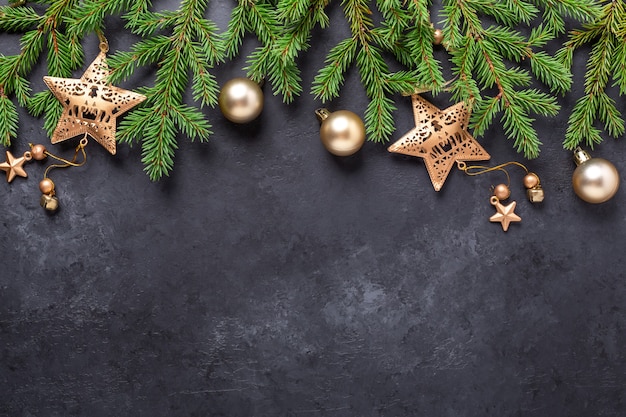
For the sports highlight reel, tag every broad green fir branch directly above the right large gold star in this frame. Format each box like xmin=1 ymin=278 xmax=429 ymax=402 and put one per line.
xmin=442 ymin=0 xmax=598 ymax=158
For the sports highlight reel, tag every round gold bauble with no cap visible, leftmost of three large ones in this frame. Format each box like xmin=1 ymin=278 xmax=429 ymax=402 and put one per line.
xmin=218 ymin=77 xmax=263 ymax=123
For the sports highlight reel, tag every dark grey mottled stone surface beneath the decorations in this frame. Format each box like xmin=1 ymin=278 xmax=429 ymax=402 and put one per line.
xmin=0 ymin=1 xmax=626 ymax=417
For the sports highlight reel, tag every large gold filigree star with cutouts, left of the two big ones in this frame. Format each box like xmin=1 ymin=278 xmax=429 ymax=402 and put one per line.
xmin=43 ymin=52 xmax=146 ymax=155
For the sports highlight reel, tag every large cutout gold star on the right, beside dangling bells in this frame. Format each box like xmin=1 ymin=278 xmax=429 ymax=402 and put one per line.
xmin=388 ymin=94 xmax=491 ymax=191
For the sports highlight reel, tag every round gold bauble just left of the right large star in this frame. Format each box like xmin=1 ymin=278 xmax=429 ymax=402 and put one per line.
xmin=315 ymin=109 xmax=365 ymax=156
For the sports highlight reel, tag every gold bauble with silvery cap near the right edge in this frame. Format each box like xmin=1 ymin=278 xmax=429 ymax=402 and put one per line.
xmin=572 ymin=148 xmax=619 ymax=204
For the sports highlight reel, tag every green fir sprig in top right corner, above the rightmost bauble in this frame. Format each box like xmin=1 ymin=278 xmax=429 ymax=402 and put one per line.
xmin=557 ymin=1 xmax=626 ymax=149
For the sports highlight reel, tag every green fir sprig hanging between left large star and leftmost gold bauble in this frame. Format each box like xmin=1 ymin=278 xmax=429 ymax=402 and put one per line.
xmin=109 ymin=0 xmax=224 ymax=180
